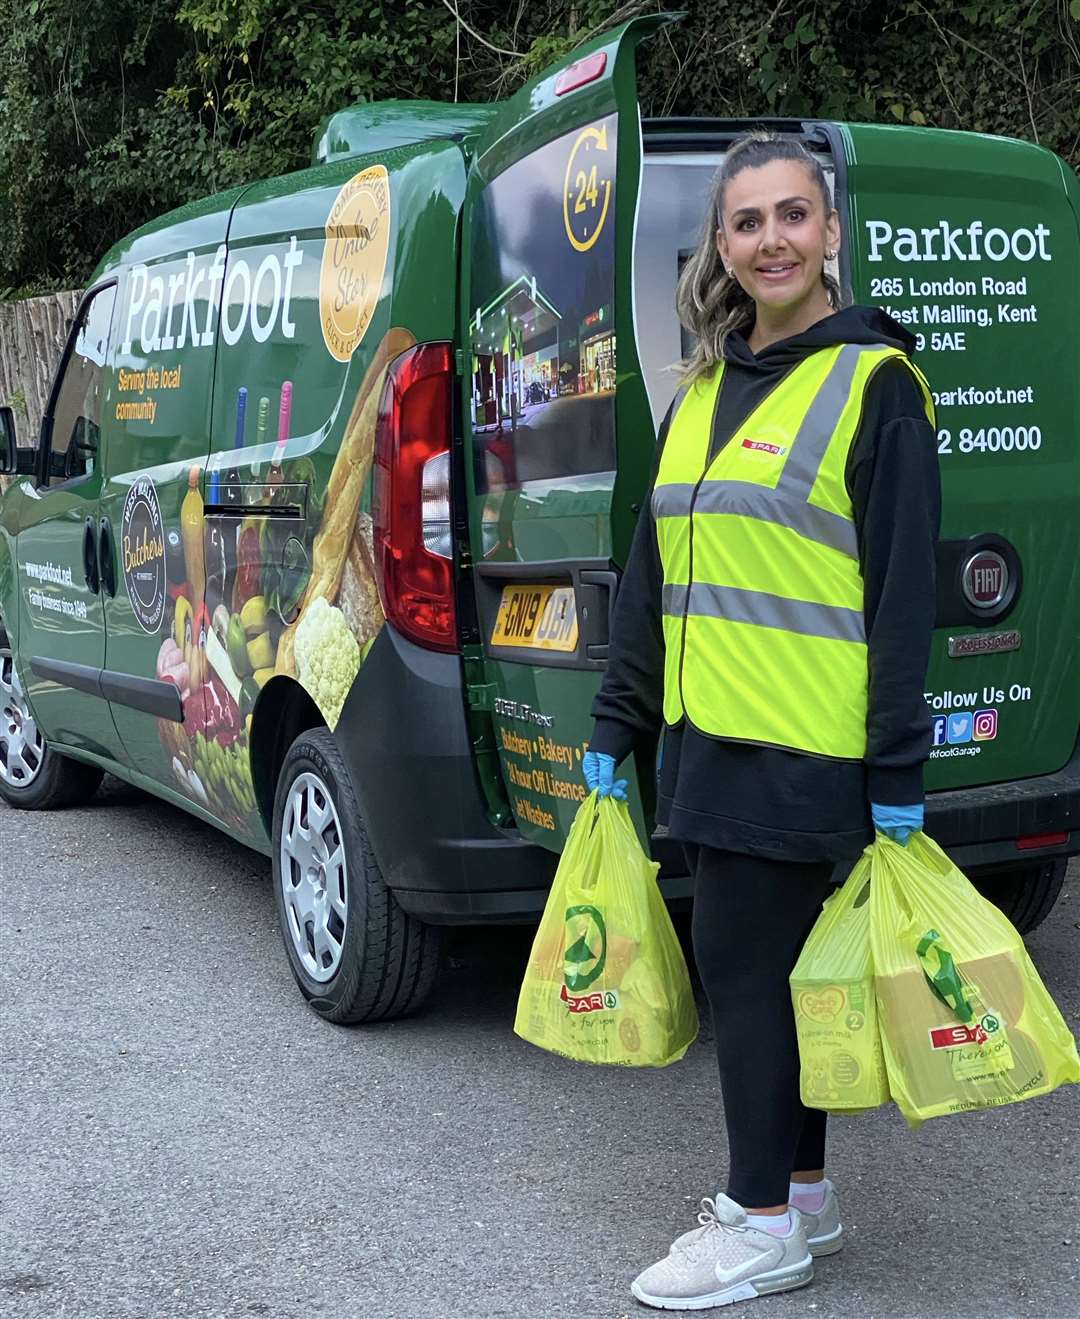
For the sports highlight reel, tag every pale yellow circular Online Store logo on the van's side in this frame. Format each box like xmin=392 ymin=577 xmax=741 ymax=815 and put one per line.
xmin=319 ymin=165 xmax=390 ymax=361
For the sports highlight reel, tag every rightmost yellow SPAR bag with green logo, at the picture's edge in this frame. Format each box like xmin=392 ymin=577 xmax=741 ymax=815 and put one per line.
xmin=870 ymin=834 xmax=1080 ymax=1126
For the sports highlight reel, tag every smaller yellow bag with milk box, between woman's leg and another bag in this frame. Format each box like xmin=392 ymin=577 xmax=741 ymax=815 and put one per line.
xmin=791 ymin=847 xmax=889 ymax=1113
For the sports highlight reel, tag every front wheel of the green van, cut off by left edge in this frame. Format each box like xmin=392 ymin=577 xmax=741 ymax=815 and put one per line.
xmin=0 ymin=640 xmax=104 ymax=811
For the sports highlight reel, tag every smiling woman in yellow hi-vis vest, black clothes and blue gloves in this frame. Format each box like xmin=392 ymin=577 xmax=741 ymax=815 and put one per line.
xmin=583 ymin=133 xmax=940 ymax=1310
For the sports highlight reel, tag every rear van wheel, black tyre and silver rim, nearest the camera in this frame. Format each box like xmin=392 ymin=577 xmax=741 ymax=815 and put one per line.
xmin=273 ymin=728 xmax=442 ymax=1025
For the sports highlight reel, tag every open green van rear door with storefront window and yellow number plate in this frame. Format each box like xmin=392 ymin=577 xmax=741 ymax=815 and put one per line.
xmin=462 ymin=17 xmax=667 ymax=851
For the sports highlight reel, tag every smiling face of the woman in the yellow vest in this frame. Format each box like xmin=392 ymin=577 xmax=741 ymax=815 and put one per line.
xmin=716 ymin=161 xmax=840 ymax=311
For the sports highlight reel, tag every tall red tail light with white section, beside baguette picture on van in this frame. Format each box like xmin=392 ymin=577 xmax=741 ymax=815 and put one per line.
xmin=372 ymin=343 xmax=458 ymax=650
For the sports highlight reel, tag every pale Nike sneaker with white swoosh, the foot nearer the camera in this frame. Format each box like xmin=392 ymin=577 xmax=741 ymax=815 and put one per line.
xmin=630 ymin=1195 xmax=814 ymax=1310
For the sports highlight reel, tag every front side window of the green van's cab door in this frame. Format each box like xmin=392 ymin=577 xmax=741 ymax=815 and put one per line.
xmin=45 ymin=284 xmax=116 ymax=485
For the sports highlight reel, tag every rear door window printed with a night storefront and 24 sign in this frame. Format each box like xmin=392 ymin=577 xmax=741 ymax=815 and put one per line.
xmin=469 ymin=115 xmax=617 ymax=493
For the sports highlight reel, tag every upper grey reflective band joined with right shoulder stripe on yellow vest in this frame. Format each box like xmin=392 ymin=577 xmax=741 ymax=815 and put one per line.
xmin=653 ymin=343 xmax=865 ymax=559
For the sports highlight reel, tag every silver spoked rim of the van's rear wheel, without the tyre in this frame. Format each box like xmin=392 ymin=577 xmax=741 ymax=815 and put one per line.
xmin=281 ymin=773 xmax=348 ymax=981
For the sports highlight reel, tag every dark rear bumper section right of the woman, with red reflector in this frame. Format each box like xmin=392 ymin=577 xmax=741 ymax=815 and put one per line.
xmin=926 ymin=743 xmax=1080 ymax=871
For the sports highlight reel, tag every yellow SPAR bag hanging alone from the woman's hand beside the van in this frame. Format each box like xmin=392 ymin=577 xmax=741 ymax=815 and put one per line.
xmin=514 ymin=793 xmax=698 ymax=1067
